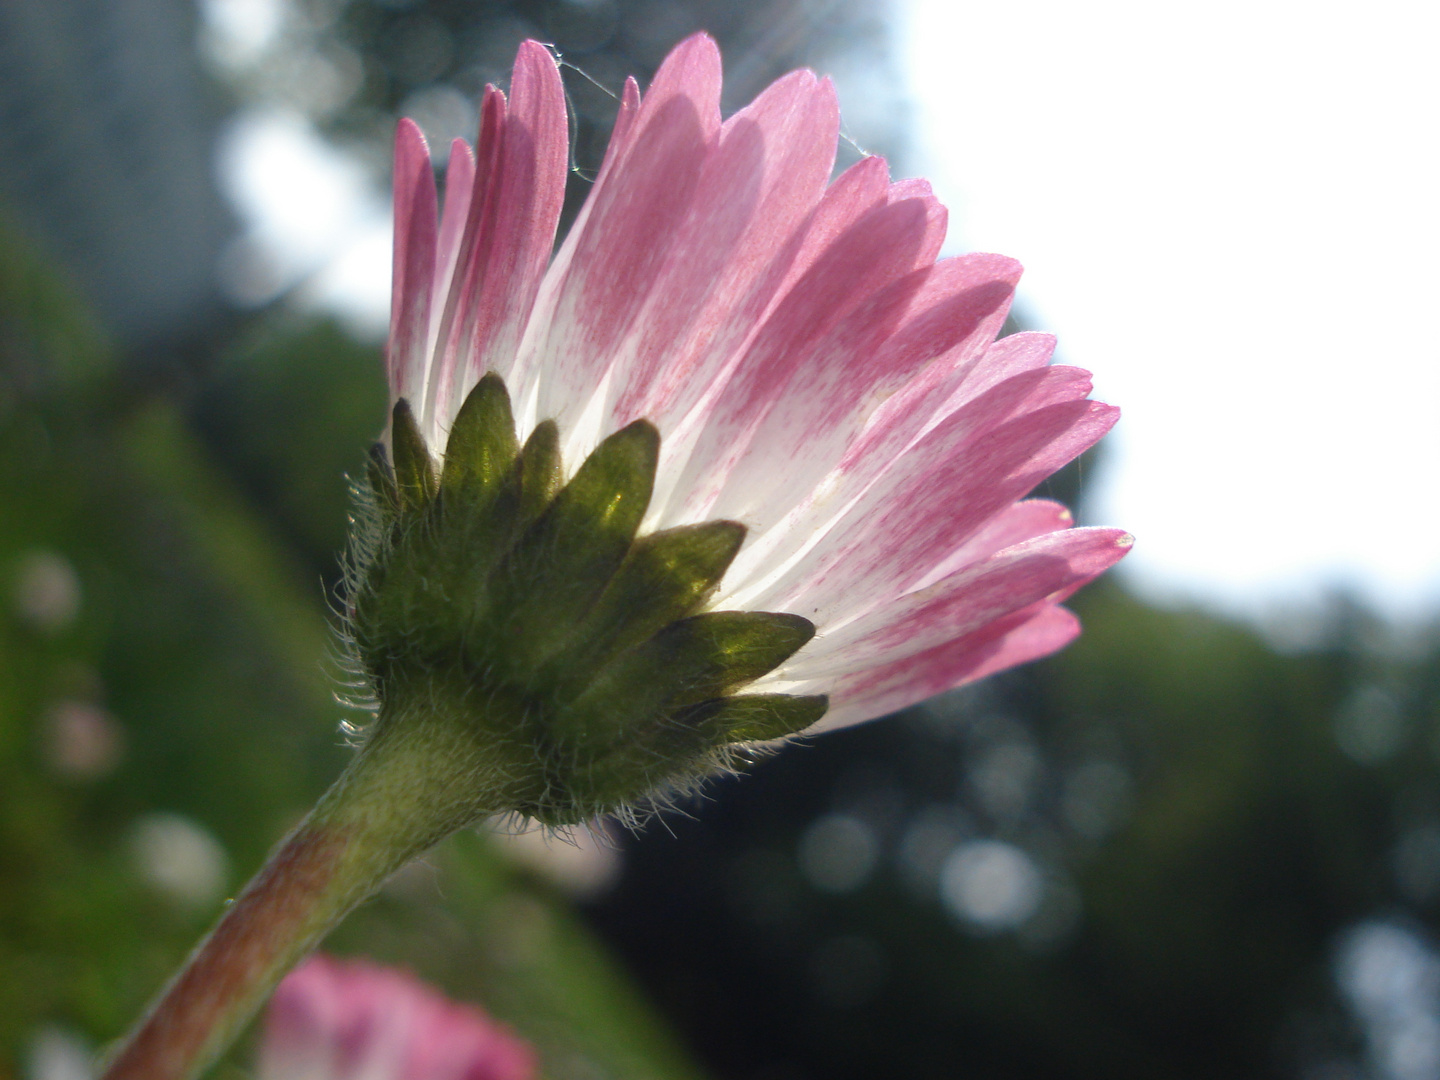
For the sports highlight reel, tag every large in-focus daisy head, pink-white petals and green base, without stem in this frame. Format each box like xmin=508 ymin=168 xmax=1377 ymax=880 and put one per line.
xmin=353 ymin=35 xmax=1130 ymax=822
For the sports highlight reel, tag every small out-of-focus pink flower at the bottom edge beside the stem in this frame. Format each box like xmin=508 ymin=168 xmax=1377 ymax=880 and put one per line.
xmin=259 ymin=956 xmax=536 ymax=1080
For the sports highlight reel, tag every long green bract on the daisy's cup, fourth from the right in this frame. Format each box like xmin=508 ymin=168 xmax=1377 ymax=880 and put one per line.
xmin=487 ymin=420 xmax=660 ymax=680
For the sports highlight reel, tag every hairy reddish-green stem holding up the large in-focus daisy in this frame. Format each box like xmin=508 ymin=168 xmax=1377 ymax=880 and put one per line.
xmin=104 ymin=713 xmax=501 ymax=1080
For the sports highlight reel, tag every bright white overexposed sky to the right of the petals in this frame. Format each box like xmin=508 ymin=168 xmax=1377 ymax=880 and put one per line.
xmin=896 ymin=0 xmax=1440 ymax=615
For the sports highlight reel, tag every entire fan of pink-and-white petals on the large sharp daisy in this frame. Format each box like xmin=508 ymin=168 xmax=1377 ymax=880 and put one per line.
xmin=387 ymin=35 xmax=1130 ymax=730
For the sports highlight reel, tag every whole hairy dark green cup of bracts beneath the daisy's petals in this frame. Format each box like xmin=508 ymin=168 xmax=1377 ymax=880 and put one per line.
xmin=350 ymin=374 xmax=827 ymax=825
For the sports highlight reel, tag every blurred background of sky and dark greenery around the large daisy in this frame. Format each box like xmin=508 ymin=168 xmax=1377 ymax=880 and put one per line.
xmin=0 ymin=0 xmax=1440 ymax=1080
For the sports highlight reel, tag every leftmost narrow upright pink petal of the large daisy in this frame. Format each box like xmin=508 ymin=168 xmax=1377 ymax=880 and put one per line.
xmin=386 ymin=120 xmax=436 ymax=403
